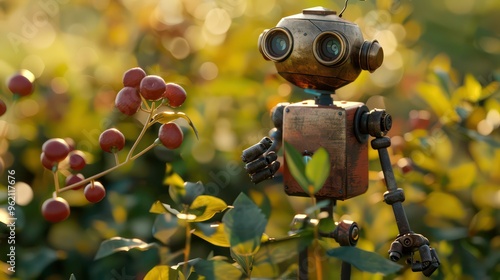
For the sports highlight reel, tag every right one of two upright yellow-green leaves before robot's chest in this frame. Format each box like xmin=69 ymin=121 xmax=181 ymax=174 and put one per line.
xmin=306 ymin=147 xmax=330 ymax=195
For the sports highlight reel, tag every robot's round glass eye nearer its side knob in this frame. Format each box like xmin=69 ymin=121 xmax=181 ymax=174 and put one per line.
xmin=313 ymin=32 xmax=348 ymax=66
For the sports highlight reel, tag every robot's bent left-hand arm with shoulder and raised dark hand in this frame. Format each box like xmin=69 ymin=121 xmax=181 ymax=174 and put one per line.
xmin=241 ymin=103 xmax=288 ymax=184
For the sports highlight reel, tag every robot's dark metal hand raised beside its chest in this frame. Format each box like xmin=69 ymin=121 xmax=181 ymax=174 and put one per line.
xmin=241 ymin=137 xmax=280 ymax=184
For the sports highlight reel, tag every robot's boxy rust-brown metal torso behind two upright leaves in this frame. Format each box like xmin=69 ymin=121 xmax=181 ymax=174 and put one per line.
xmin=283 ymin=100 xmax=368 ymax=200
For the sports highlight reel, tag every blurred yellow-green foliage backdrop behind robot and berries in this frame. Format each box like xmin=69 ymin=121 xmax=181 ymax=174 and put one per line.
xmin=0 ymin=0 xmax=500 ymax=279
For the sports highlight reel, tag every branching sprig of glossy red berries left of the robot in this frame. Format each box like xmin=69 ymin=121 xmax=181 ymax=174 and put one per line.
xmin=40 ymin=67 xmax=197 ymax=222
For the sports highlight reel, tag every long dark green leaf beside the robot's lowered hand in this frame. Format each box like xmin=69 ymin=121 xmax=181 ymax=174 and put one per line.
xmin=326 ymin=247 xmax=402 ymax=275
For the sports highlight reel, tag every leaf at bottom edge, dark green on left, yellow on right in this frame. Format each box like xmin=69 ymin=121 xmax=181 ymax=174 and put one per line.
xmin=194 ymin=260 xmax=242 ymax=280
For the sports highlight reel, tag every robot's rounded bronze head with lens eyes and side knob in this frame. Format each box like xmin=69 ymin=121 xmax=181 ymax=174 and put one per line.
xmin=259 ymin=7 xmax=384 ymax=91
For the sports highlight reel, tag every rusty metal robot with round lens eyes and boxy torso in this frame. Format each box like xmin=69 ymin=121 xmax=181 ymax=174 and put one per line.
xmin=242 ymin=7 xmax=440 ymax=279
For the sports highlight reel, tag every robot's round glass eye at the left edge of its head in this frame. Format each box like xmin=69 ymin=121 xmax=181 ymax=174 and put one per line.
xmin=259 ymin=27 xmax=293 ymax=62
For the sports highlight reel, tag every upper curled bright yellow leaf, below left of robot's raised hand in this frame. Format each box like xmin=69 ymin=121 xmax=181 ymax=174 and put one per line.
xmin=188 ymin=195 xmax=227 ymax=222
